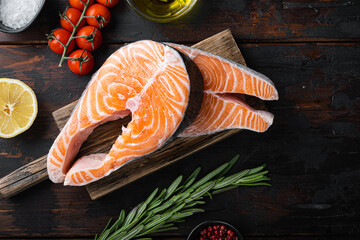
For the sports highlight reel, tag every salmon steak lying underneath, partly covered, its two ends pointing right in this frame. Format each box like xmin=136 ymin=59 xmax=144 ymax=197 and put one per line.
xmin=166 ymin=43 xmax=279 ymax=137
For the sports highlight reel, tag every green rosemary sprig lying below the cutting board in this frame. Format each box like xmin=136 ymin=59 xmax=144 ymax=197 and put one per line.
xmin=95 ymin=155 xmax=270 ymax=240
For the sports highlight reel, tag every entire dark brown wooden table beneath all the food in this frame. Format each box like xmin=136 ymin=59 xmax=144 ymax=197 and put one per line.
xmin=0 ymin=0 xmax=360 ymax=240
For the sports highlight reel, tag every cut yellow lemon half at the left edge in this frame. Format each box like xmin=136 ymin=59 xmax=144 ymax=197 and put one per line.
xmin=0 ymin=78 xmax=38 ymax=138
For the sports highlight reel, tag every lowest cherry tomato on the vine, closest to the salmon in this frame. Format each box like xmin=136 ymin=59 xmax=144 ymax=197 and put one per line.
xmin=68 ymin=49 xmax=95 ymax=75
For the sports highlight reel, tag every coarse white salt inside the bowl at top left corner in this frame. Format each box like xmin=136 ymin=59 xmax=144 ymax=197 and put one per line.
xmin=0 ymin=0 xmax=42 ymax=29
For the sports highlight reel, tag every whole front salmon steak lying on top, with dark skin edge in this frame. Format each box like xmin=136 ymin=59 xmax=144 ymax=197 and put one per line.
xmin=47 ymin=40 xmax=203 ymax=186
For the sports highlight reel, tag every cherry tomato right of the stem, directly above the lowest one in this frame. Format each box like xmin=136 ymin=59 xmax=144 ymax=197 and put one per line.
xmin=76 ymin=26 xmax=102 ymax=51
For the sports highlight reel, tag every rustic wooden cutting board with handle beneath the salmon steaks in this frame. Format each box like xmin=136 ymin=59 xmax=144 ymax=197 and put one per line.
xmin=0 ymin=30 xmax=265 ymax=199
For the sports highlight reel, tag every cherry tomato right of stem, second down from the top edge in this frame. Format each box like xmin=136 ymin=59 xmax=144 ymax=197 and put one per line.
xmin=85 ymin=4 xmax=111 ymax=29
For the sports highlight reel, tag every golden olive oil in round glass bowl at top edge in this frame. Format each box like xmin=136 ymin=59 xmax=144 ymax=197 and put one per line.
xmin=133 ymin=0 xmax=196 ymax=19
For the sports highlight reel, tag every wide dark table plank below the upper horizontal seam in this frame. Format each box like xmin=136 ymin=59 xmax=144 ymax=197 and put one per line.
xmin=0 ymin=43 xmax=360 ymax=238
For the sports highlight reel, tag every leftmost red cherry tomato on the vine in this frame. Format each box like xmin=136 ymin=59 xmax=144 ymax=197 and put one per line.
xmin=48 ymin=28 xmax=75 ymax=54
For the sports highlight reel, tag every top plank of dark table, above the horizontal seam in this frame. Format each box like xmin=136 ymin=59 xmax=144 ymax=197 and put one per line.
xmin=0 ymin=0 xmax=360 ymax=44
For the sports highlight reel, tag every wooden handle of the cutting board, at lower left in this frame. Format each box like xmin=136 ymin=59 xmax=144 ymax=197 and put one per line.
xmin=0 ymin=155 xmax=48 ymax=198
